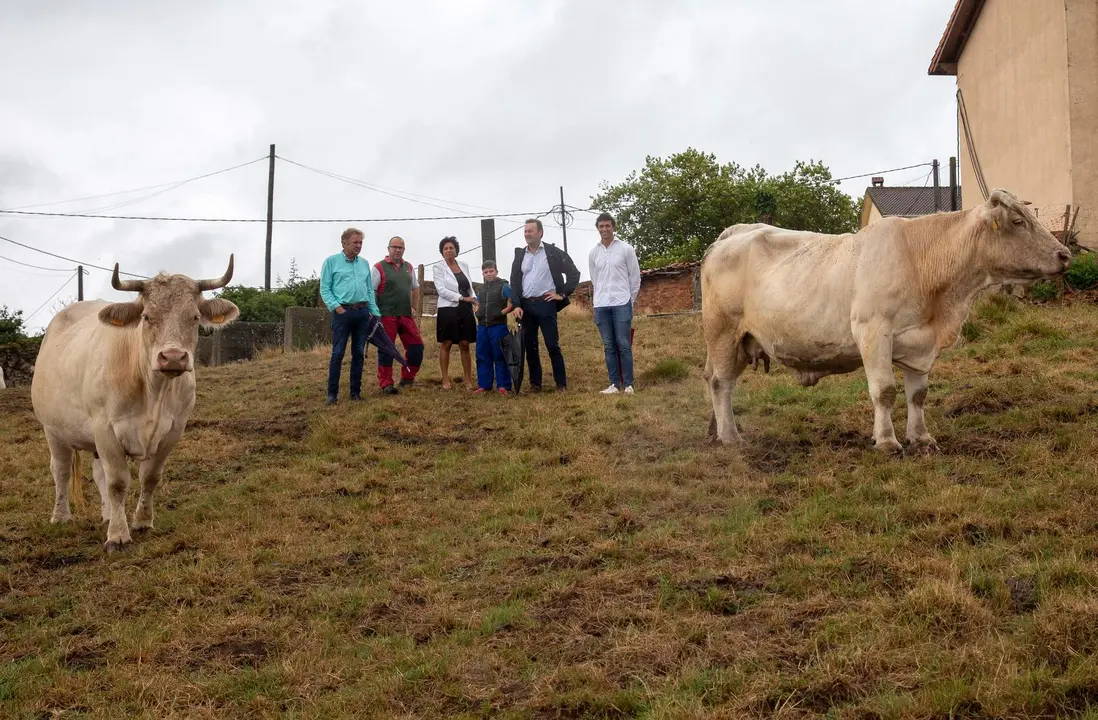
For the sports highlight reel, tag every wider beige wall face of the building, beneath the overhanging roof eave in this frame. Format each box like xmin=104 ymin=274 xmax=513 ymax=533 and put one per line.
xmin=956 ymin=0 xmax=1071 ymax=214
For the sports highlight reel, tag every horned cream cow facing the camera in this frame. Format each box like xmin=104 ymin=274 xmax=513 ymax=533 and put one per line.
xmin=31 ymin=255 xmax=239 ymax=552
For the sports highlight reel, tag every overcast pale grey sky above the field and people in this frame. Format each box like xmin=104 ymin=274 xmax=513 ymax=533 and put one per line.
xmin=0 ymin=0 xmax=956 ymax=328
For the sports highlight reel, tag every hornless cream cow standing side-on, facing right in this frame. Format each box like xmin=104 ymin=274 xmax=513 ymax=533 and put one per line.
xmin=702 ymin=190 xmax=1072 ymax=453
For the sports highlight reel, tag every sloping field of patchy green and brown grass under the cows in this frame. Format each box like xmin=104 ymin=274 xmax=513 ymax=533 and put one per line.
xmin=0 ymin=297 xmax=1098 ymax=718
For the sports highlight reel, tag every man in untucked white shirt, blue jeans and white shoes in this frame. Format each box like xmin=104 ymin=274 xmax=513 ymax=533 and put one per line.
xmin=587 ymin=213 xmax=640 ymax=395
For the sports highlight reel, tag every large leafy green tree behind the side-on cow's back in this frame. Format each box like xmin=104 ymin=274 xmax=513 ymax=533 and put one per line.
xmin=591 ymin=148 xmax=859 ymax=267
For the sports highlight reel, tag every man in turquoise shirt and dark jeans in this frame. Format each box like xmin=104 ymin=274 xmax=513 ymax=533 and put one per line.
xmin=321 ymin=227 xmax=381 ymax=405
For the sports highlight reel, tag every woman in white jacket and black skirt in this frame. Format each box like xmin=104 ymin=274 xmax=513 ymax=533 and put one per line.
xmin=432 ymin=236 xmax=477 ymax=390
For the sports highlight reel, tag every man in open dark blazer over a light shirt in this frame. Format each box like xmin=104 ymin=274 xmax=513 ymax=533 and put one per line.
xmin=511 ymin=218 xmax=580 ymax=393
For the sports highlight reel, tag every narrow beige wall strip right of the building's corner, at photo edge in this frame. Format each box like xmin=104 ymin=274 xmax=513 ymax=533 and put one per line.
xmin=1062 ymin=0 xmax=1098 ymax=248
